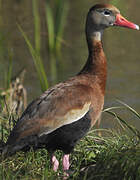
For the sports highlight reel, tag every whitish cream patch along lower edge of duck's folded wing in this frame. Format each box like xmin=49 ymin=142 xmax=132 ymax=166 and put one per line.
xmin=39 ymin=102 xmax=91 ymax=136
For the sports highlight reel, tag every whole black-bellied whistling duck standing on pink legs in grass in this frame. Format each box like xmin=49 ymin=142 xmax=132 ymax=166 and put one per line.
xmin=2 ymin=4 xmax=139 ymax=174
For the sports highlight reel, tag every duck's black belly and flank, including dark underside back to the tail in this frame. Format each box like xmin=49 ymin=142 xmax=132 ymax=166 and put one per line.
xmin=6 ymin=113 xmax=91 ymax=155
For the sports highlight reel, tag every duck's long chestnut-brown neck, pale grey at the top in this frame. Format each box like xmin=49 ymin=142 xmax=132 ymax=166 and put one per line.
xmin=79 ymin=32 xmax=107 ymax=93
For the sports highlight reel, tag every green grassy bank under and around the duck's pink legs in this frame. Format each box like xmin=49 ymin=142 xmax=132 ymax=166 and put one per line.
xmin=0 ymin=100 xmax=140 ymax=180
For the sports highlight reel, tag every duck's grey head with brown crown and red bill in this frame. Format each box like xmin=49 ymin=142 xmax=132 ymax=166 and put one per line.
xmin=86 ymin=4 xmax=139 ymax=39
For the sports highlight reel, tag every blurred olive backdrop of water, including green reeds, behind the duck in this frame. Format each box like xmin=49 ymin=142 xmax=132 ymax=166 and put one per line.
xmin=0 ymin=0 xmax=140 ymax=129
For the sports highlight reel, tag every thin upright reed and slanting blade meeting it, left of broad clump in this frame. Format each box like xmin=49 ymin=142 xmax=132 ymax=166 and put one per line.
xmin=18 ymin=0 xmax=49 ymax=91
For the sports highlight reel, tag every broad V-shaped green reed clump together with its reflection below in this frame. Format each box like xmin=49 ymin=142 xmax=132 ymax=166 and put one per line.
xmin=45 ymin=0 xmax=68 ymax=83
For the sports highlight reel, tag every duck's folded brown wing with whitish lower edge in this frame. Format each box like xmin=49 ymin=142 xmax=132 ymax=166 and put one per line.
xmin=7 ymin=83 xmax=91 ymax=144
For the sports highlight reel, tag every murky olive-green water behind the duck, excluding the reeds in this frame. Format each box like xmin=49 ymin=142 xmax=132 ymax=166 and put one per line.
xmin=0 ymin=0 xmax=140 ymax=128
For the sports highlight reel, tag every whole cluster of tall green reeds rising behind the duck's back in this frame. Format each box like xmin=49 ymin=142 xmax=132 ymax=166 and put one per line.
xmin=18 ymin=0 xmax=68 ymax=89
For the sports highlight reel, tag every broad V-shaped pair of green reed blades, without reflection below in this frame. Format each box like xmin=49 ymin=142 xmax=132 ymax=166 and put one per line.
xmin=45 ymin=0 xmax=68 ymax=56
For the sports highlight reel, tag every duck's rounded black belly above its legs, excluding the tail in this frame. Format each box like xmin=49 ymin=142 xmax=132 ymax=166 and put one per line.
xmin=40 ymin=113 xmax=91 ymax=154
